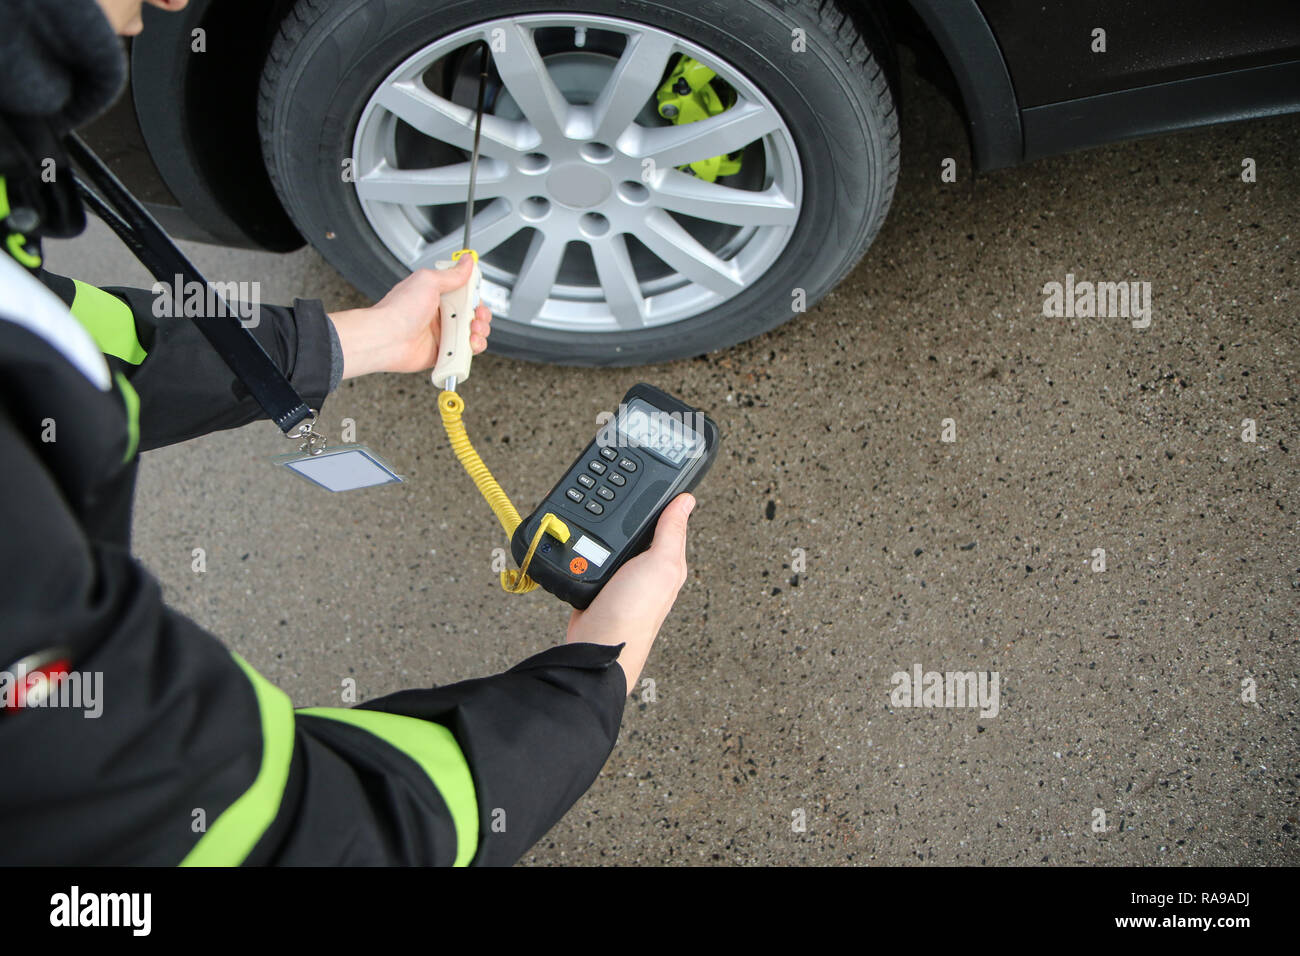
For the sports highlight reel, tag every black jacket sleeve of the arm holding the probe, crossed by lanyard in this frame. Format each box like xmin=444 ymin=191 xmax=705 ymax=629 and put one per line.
xmin=39 ymin=272 xmax=343 ymax=451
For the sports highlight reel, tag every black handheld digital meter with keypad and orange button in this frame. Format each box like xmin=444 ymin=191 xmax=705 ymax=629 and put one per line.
xmin=510 ymin=382 xmax=719 ymax=610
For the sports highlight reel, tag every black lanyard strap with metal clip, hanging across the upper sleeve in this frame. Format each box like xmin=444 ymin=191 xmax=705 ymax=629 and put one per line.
xmin=66 ymin=134 xmax=325 ymax=455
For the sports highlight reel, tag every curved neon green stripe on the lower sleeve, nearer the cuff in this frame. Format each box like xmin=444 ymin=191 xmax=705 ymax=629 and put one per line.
xmin=298 ymin=708 xmax=478 ymax=866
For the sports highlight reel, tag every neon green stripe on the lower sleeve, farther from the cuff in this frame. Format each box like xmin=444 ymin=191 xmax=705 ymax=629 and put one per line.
xmin=181 ymin=654 xmax=294 ymax=866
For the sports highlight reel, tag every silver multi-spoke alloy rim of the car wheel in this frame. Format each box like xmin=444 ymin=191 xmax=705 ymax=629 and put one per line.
xmin=352 ymin=14 xmax=802 ymax=333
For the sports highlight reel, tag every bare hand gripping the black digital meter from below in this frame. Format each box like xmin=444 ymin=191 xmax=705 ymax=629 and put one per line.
xmin=564 ymin=494 xmax=696 ymax=693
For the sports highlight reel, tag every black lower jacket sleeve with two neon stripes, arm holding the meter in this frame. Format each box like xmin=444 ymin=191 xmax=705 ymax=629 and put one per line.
xmin=0 ymin=408 xmax=625 ymax=865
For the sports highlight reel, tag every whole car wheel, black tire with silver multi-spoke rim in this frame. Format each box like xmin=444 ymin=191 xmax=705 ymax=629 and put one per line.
xmin=259 ymin=0 xmax=898 ymax=365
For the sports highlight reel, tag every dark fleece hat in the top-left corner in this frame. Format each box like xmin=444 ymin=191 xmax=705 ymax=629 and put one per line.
xmin=0 ymin=0 xmax=126 ymax=135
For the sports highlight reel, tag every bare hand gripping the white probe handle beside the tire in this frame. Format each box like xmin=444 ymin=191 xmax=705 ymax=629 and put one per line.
xmin=330 ymin=255 xmax=491 ymax=378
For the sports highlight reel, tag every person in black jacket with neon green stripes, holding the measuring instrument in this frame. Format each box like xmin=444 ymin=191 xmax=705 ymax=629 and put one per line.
xmin=0 ymin=0 xmax=694 ymax=865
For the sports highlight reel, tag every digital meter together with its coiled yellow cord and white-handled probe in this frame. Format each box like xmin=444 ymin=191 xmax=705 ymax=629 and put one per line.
xmin=432 ymin=43 xmax=719 ymax=610
